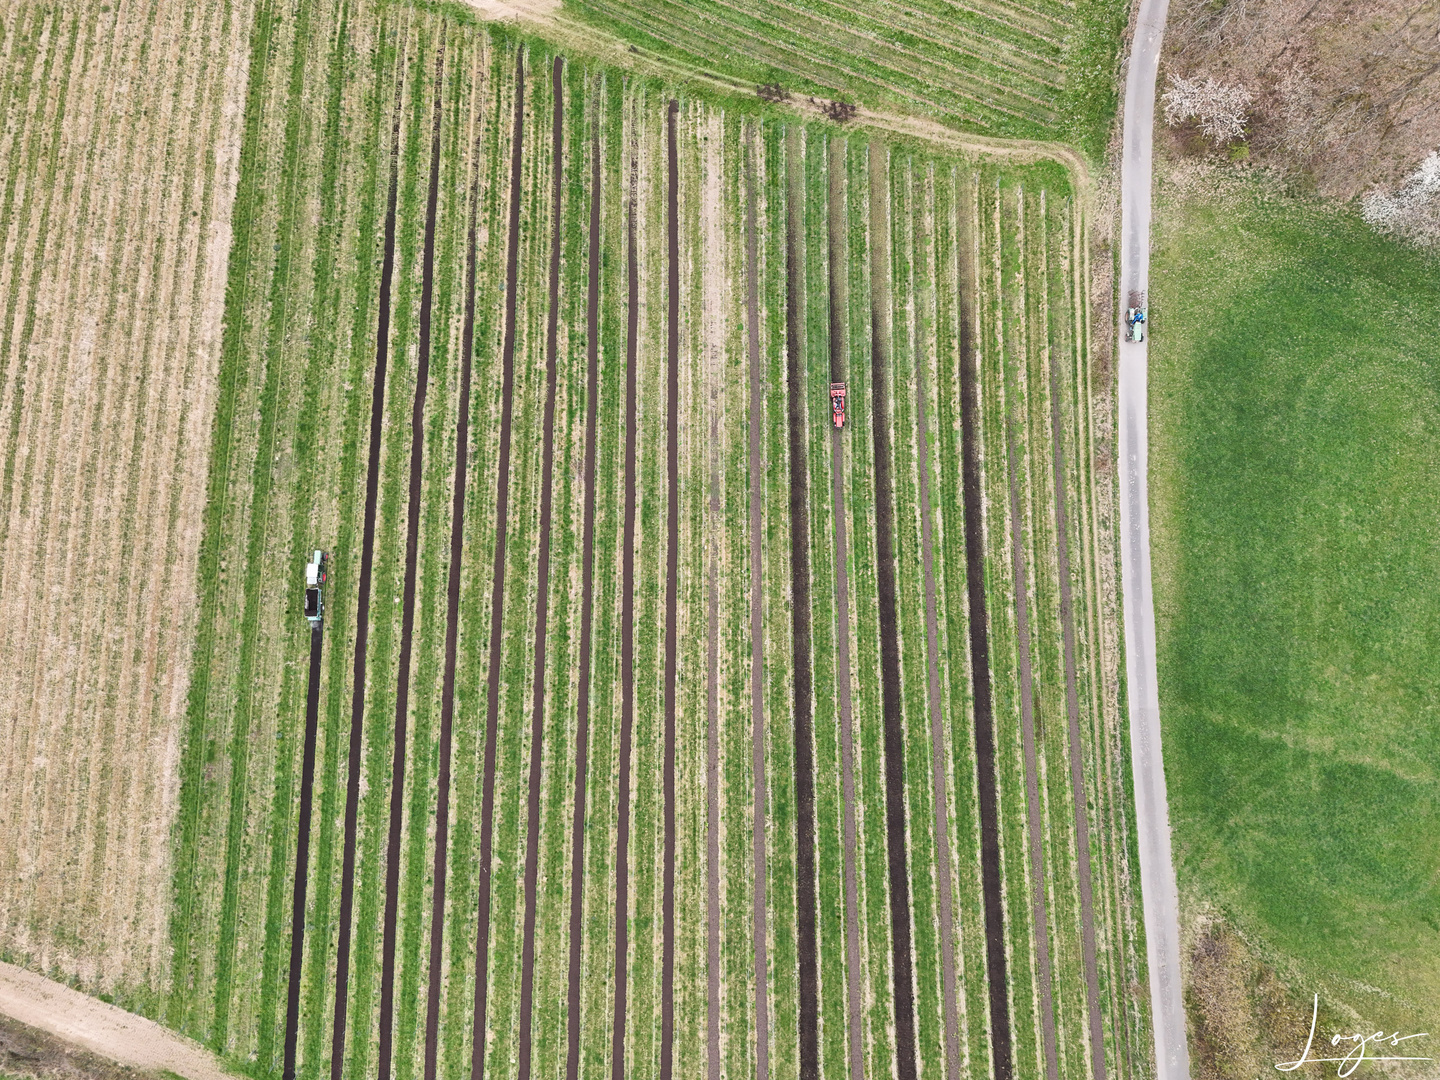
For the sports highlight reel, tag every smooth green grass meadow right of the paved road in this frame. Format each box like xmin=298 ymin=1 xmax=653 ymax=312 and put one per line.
xmin=1151 ymin=181 xmax=1440 ymax=1031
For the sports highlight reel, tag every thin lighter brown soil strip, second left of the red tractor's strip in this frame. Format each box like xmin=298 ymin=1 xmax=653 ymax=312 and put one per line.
xmin=748 ymin=130 xmax=770 ymax=1080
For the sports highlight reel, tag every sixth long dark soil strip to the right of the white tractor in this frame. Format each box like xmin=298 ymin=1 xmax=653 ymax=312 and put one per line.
xmin=561 ymin=95 xmax=600 ymax=1080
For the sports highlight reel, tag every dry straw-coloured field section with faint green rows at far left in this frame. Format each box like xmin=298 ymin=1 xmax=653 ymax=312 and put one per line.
xmin=0 ymin=0 xmax=249 ymax=991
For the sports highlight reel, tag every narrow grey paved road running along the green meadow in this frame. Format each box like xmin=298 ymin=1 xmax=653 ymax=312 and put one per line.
xmin=1119 ymin=0 xmax=1189 ymax=1080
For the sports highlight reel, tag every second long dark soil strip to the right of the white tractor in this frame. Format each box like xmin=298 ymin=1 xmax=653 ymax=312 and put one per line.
xmin=379 ymin=33 xmax=445 ymax=1080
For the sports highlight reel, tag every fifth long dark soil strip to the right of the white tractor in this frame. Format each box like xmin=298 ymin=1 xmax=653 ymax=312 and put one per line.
xmin=518 ymin=56 xmax=564 ymax=1080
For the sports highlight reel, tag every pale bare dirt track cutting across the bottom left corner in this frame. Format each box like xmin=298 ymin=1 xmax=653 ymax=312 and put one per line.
xmin=0 ymin=960 xmax=232 ymax=1080
